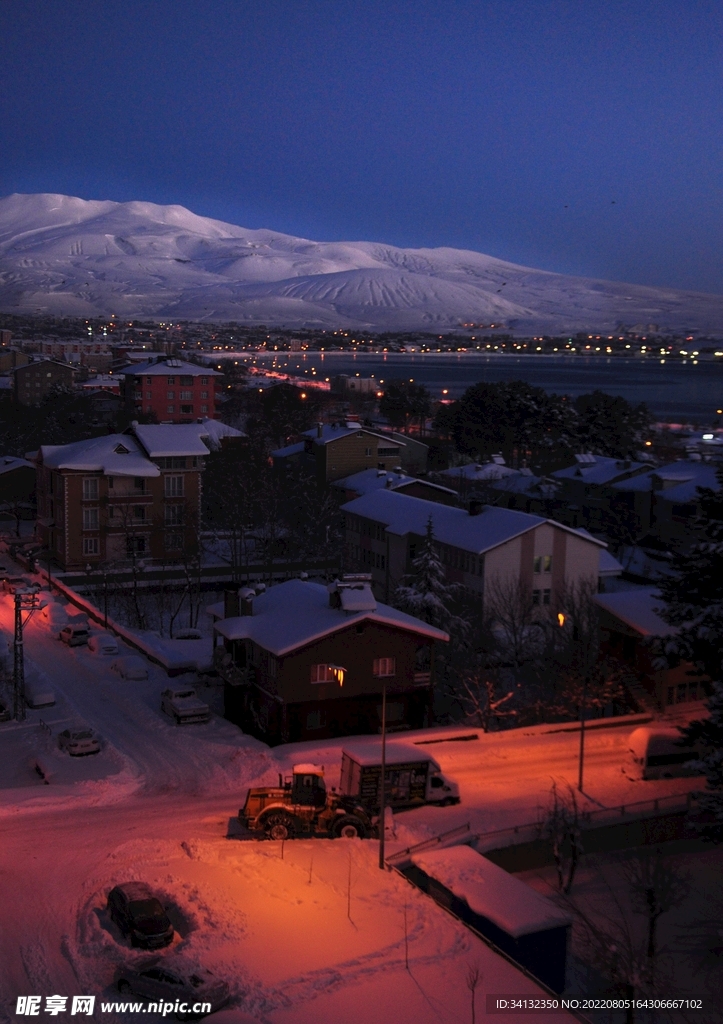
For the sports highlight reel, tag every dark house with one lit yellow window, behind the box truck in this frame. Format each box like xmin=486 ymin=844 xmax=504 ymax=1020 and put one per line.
xmin=209 ymin=575 xmax=449 ymax=743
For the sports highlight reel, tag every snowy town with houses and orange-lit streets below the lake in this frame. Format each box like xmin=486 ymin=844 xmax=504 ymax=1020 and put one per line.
xmin=0 ymin=332 xmax=723 ymax=1024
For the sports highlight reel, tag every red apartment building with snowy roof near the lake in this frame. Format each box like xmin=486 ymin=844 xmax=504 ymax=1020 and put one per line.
xmin=120 ymin=358 xmax=222 ymax=423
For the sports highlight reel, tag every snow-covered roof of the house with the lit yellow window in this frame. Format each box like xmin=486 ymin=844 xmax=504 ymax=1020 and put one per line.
xmin=213 ymin=580 xmax=450 ymax=657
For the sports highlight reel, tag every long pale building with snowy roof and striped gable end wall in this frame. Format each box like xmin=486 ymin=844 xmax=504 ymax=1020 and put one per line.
xmin=342 ymin=489 xmax=606 ymax=605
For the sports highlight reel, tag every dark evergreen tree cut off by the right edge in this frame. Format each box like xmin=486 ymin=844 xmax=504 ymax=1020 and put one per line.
xmin=660 ymin=470 xmax=723 ymax=843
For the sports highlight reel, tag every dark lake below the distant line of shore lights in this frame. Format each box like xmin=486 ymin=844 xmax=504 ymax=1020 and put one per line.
xmin=229 ymin=352 xmax=723 ymax=424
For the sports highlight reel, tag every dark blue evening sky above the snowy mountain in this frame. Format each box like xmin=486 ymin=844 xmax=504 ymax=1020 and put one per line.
xmin=0 ymin=0 xmax=723 ymax=292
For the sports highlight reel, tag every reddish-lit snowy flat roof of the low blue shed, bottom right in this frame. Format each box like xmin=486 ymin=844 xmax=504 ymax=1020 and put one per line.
xmin=412 ymin=846 xmax=572 ymax=939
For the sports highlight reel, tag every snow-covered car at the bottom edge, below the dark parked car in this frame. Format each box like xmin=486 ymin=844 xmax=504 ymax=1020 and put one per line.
xmin=115 ymin=957 xmax=228 ymax=1020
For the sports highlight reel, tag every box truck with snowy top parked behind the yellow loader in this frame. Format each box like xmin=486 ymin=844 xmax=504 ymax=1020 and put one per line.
xmin=339 ymin=739 xmax=460 ymax=813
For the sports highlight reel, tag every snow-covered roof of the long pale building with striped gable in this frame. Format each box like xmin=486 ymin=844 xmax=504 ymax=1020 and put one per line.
xmin=342 ymin=489 xmax=604 ymax=554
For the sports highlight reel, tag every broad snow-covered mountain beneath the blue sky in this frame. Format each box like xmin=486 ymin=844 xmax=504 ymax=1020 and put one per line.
xmin=0 ymin=194 xmax=723 ymax=334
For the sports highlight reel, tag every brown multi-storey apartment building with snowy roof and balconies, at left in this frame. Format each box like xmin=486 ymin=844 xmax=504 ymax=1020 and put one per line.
xmin=34 ymin=424 xmax=214 ymax=569
